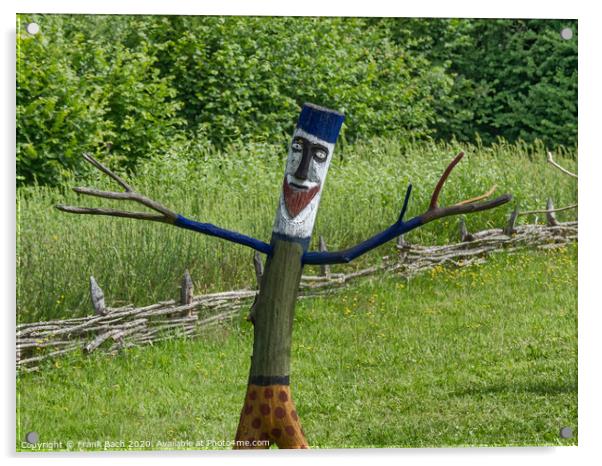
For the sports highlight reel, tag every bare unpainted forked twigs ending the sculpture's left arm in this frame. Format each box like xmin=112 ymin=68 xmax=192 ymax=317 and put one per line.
xmin=56 ymin=154 xmax=177 ymax=224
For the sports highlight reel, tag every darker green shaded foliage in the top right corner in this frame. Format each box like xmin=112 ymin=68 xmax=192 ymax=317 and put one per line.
xmin=383 ymin=19 xmax=577 ymax=147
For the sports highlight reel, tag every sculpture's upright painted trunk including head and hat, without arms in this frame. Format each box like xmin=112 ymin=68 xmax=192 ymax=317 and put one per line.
xmin=236 ymin=104 xmax=343 ymax=448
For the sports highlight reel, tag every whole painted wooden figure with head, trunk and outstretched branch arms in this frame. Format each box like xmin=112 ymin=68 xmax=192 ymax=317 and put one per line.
xmin=57 ymin=104 xmax=511 ymax=448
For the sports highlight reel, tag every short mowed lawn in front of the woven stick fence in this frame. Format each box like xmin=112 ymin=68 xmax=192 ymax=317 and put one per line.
xmin=17 ymin=246 xmax=577 ymax=449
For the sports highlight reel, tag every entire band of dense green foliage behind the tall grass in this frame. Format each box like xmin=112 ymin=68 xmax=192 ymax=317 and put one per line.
xmin=17 ymin=15 xmax=577 ymax=184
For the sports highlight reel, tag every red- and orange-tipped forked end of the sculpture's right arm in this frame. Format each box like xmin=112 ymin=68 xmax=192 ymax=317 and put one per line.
xmin=420 ymin=152 xmax=512 ymax=224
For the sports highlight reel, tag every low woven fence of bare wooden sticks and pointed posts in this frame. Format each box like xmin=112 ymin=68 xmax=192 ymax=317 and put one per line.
xmin=16 ymin=200 xmax=578 ymax=371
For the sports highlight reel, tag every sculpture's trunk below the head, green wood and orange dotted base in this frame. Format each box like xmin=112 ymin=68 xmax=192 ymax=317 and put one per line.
xmin=236 ymin=239 xmax=307 ymax=448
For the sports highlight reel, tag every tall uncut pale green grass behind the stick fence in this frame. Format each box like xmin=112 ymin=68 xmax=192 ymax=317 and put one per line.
xmin=17 ymin=139 xmax=577 ymax=322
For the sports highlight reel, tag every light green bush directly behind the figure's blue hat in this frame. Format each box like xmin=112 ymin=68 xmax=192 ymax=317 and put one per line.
xmin=145 ymin=17 xmax=451 ymax=146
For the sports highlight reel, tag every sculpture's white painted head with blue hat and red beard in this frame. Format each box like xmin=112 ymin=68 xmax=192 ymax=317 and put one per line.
xmin=273 ymin=104 xmax=345 ymax=240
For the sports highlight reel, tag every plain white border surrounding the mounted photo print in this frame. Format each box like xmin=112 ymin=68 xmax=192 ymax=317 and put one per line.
xmin=0 ymin=0 xmax=602 ymax=466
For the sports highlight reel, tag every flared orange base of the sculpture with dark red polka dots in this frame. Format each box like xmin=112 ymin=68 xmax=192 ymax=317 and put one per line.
xmin=235 ymin=385 xmax=308 ymax=449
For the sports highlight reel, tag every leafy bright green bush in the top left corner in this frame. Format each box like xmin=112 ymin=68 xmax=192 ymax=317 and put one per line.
xmin=17 ymin=15 xmax=182 ymax=184
